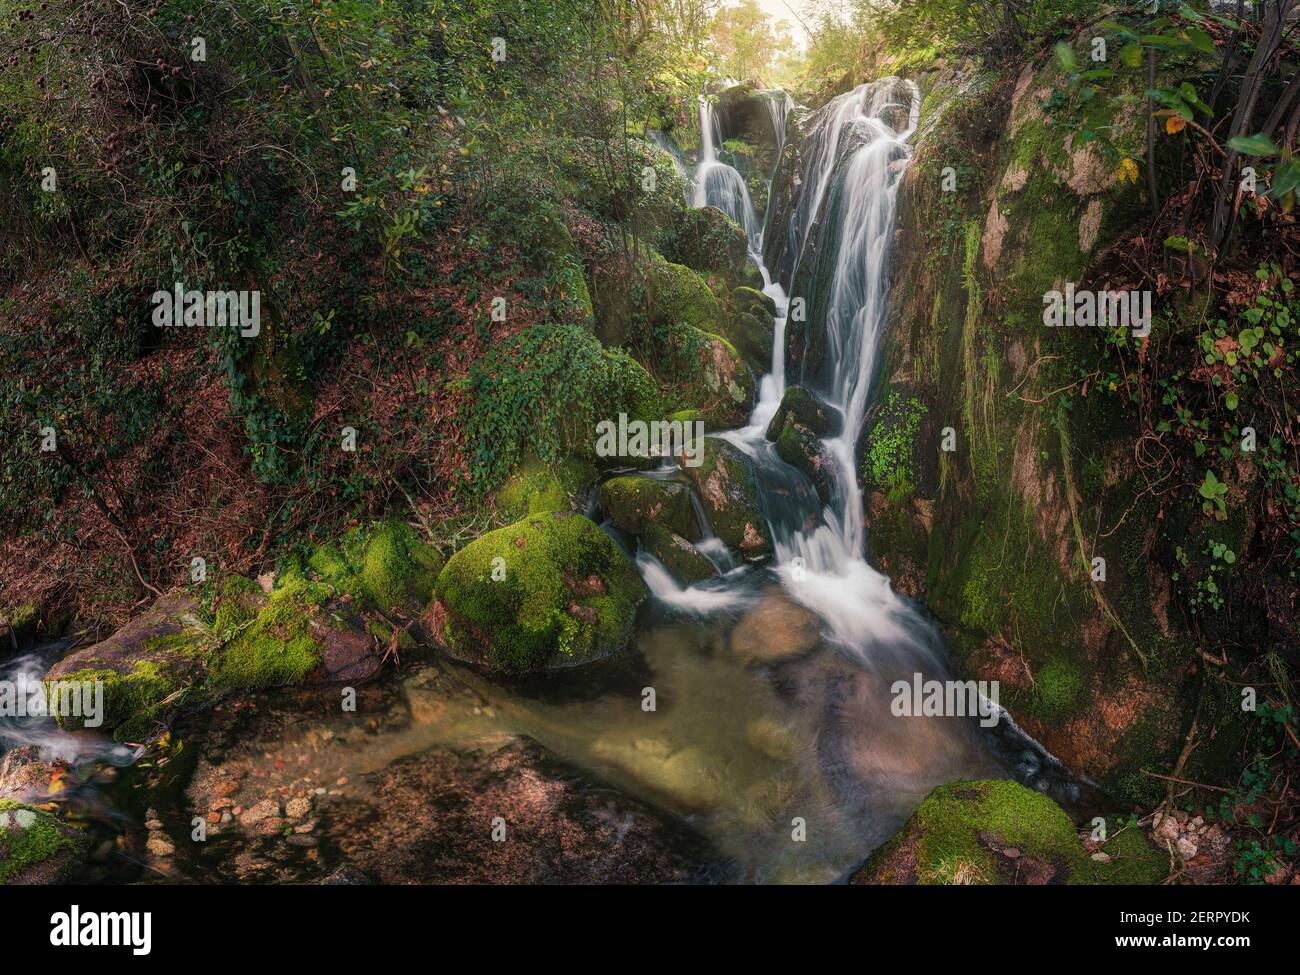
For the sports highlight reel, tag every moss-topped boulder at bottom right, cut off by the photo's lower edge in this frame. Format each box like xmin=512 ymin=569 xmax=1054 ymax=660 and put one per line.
xmin=850 ymin=780 xmax=1169 ymax=884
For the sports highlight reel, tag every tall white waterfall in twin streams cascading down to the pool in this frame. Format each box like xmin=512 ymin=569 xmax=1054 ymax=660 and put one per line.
xmin=694 ymin=78 xmax=939 ymax=662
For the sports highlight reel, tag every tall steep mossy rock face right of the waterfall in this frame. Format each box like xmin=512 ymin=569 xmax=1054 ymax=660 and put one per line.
xmin=859 ymin=62 xmax=1249 ymax=805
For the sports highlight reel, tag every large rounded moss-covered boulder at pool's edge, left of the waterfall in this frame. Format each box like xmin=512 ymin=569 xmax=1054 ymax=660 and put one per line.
xmin=429 ymin=512 xmax=645 ymax=673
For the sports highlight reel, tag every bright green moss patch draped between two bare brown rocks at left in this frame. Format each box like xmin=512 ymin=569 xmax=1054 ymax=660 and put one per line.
xmin=212 ymin=572 xmax=330 ymax=690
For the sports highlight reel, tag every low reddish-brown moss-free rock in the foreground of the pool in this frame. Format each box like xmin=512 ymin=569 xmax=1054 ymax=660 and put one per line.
xmin=329 ymin=740 xmax=711 ymax=884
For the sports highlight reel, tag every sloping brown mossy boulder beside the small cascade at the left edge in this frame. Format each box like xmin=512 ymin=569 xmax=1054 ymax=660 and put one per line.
xmin=46 ymin=595 xmax=206 ymax=741
